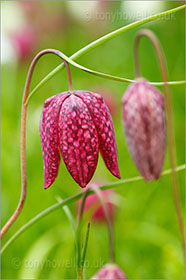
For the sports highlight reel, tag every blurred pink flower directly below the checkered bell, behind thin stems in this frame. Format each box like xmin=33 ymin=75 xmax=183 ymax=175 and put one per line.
xmin=78 ymin=184 xmax=116 ymax=222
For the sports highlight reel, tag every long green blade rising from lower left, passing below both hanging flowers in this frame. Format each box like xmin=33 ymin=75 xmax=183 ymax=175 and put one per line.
xmin=1 ymin=164 xmax=185 ymax=253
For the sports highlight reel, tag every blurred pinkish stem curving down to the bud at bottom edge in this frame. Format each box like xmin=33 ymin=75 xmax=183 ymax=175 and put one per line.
xmin=91 ymin=186 xmax=115 ymax=263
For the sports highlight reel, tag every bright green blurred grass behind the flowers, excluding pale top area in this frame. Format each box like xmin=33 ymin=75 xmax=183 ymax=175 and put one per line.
xmin=1 ymin=2 xmax=185 ymax=279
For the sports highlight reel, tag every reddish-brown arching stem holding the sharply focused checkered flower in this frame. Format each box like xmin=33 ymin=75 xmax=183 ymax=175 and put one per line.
xmin=0 ymin=49 xmax=73 ymax=239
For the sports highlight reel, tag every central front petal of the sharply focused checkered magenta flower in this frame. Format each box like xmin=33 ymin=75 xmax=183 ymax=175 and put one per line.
xmin=59 ymin=94 xmax=98 ymax=187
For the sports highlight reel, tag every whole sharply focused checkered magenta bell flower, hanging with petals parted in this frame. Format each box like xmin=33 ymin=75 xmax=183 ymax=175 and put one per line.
xmin=40 ymin=90 xmax=120 ymax=189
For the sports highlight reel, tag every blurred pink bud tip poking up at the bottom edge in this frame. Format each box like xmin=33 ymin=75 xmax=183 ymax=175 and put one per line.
xmin=91 ymin=264 xmax=127 ymax=280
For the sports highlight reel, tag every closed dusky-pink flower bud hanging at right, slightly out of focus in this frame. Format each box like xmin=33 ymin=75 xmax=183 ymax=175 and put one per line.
xmin=122 ymin=78 xmax=166 ymax=181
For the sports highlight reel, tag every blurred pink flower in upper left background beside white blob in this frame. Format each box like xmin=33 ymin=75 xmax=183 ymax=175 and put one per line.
xmin=11 ymin=26 xmax=37 ymax=60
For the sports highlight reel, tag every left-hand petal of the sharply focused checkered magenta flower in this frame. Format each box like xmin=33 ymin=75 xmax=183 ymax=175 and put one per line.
xmin=40 ymin=92 xmax=69 ymax=189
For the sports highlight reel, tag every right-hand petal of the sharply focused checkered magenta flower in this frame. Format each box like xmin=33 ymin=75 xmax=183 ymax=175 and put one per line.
xmin=76 ymin=91 xmax=120 ymax=179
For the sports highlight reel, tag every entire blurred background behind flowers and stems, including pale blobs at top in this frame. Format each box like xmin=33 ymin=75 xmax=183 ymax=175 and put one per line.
xmin=1 ymin=1 xmax=185 ymax=279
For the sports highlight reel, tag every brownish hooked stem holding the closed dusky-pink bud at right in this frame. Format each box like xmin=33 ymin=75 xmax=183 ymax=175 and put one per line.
xmin=134 ymin=29 xmax=185 ymax=256
